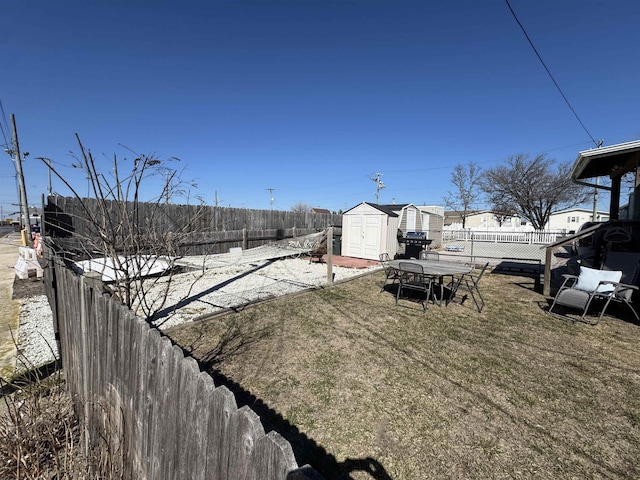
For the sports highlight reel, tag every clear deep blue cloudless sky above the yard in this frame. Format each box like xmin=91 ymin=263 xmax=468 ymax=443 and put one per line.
xmin=0 ymin=0 xmax=640 ymax=215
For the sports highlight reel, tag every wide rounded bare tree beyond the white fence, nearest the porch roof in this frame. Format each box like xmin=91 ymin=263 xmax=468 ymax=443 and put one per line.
xmin=481 ymin=154 xmax=589 ymax=230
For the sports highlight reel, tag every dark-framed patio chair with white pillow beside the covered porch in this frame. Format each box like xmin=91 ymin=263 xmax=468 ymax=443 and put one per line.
xmin=549 ymin=252 xmax=640 ymax=325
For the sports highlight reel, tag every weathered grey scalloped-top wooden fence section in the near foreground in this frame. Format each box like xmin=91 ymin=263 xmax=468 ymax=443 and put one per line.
xmin=45 ymin=251 xmax=321 ymax=480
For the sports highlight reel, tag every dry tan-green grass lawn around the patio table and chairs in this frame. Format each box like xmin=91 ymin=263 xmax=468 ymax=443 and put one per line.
xmin=166 ymin=272 xmax=640 ymax=479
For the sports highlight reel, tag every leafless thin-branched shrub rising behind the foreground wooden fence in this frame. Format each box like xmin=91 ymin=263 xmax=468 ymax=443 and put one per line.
xmin=42 ymin=134 xmax=204 ymax=324
